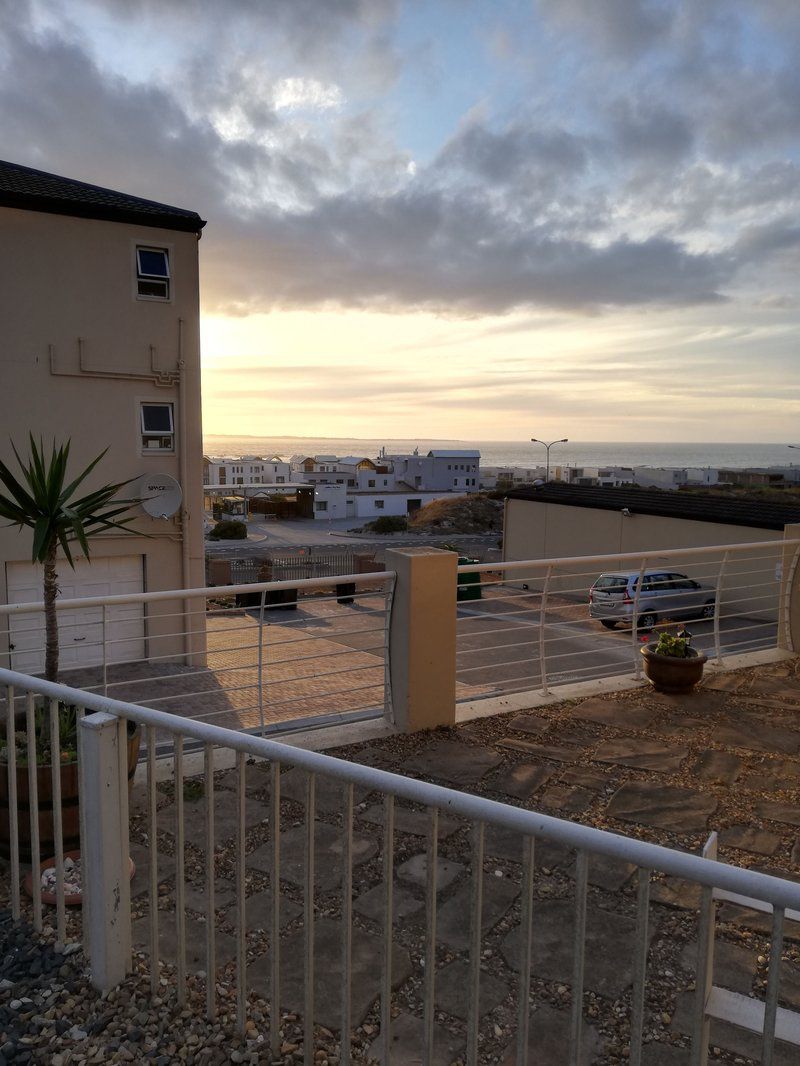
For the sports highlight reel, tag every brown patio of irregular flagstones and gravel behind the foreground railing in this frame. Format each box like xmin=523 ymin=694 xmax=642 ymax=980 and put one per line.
xmin=123 ymin=661 xmax=800 ymax=1066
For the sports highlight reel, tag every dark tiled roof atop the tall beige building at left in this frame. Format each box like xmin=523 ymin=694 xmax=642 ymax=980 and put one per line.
xmin=0 ymin=160 xmax=206 ymax=233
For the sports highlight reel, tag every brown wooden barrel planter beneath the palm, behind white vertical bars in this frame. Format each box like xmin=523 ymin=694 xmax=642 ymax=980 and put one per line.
xmin=0 ymin=727 xmax=142 ymax=862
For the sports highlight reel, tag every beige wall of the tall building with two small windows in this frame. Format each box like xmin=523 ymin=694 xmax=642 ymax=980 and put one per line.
xmin=0 ymin=202 xmax=205 ymax=655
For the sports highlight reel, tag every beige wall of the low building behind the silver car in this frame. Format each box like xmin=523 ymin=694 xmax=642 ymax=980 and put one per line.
xmin=503 ymin=500 xmax=783 ymax=620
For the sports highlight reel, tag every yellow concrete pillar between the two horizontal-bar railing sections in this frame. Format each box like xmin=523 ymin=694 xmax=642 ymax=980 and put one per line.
xmin=386 ymin=548 xmax=458 ymax=732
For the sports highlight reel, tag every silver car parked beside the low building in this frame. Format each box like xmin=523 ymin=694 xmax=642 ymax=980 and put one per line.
xmin=589 ymin=570 xmax=716 ymax=629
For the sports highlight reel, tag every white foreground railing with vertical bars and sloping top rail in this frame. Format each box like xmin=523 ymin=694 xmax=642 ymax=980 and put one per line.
xmin=0 ymin=669 xmax=800 ymax=1066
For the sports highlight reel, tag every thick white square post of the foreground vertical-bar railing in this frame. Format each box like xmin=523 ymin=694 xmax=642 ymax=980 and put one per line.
xmin=80 ymin=711 xmax=130 ymax=991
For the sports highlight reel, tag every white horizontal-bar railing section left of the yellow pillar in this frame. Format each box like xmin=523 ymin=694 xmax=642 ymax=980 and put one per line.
xmin=0 ymin=564 xmax=395 ymax=736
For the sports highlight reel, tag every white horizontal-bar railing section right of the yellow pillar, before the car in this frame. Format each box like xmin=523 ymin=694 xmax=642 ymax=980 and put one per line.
xmin=457 ymin=539 xmax=800 ymax=701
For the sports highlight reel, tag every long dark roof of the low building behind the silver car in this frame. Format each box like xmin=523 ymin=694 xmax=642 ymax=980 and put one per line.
xmin=508 ymin=483 xmax=800 ymax=530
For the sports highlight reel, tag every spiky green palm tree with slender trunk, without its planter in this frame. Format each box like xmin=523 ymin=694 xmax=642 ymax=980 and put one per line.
xmin=0 ymin=434 xmax=140 ymax=681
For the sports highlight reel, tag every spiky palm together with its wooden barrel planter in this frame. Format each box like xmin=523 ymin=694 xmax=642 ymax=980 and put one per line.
xmin=0 ymin=434 xmax=140 ymax=891
